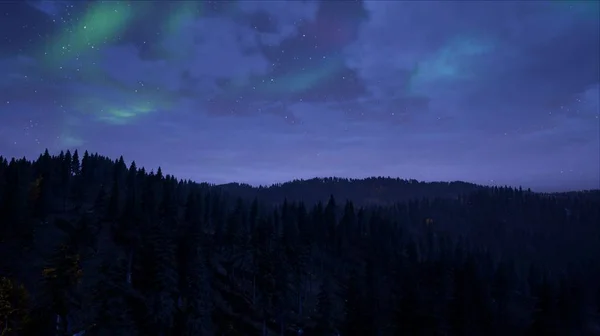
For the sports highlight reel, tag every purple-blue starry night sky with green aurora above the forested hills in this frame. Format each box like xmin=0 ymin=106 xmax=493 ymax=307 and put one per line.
xmin=0 ymin=0 xmax=600 ymax=191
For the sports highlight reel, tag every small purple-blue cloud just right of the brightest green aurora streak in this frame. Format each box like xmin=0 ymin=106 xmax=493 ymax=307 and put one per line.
xmin=100 ymin=17 xmax=268 ymax=97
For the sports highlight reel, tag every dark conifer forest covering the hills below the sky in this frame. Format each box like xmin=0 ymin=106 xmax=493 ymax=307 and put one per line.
xmin=0 ymin=151 xmax=600 ymax=336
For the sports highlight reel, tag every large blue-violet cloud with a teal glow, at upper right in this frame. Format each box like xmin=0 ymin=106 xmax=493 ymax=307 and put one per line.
xmin=346 ymin=1 xmax=600 ymax=116
